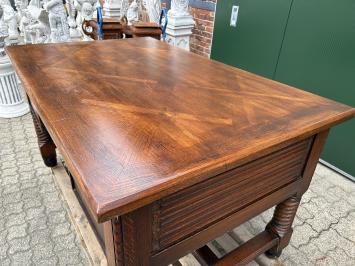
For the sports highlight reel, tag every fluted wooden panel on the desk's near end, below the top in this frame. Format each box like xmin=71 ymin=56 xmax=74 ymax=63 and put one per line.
xmin=153 ymin=139 xmax=312 ymax=251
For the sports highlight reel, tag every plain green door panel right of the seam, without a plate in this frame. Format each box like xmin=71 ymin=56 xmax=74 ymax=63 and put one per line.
xmin=274 ymin=0 xmax=355 ymax=176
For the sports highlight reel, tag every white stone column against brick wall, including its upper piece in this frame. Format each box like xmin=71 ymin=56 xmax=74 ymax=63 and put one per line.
xmin=165 ymin=0 xmax=195 ymax=50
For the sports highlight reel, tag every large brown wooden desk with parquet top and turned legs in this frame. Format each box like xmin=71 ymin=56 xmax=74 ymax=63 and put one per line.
xmin=7 ymin=38 xmax=354 ymax=266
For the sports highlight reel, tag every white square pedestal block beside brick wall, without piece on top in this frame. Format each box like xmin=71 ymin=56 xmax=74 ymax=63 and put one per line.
xmin=165 ymin=11 xmax=195 ymax=51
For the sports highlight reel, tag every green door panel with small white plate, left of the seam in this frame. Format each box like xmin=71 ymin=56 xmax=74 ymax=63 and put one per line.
xmin=211 ymin=0 xmax=292 ymax=78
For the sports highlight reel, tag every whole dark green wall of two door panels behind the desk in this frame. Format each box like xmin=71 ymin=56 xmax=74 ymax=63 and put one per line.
xmin=211 ymin=0 xmax=355 ymax=176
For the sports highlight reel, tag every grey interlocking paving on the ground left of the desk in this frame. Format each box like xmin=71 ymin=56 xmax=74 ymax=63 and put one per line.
xmin=0 ymin=114 xmax=90 ymax=266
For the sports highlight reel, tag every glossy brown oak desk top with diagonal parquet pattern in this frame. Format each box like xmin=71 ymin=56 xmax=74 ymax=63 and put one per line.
xmin=6 ymin=38 xmax=354 ymax=222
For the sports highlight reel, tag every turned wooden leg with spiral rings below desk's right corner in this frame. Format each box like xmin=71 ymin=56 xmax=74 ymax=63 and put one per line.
xmin=266 ymin=196 xmax=300 ymax=257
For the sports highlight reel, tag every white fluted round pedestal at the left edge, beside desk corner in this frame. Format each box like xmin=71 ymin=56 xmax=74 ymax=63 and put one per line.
xmin=0 ymin=56 xmax=30 ymax=118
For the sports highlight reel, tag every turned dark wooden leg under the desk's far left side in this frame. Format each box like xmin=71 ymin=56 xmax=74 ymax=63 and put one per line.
xmin=28 ymin=101 xmax=57 ymax=167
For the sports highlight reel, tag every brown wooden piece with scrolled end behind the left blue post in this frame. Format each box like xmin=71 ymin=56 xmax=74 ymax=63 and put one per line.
xmin=82 ymin=18 xmax=123 ymax=40
